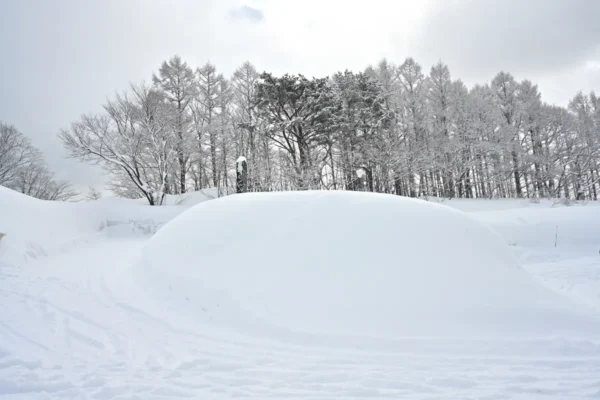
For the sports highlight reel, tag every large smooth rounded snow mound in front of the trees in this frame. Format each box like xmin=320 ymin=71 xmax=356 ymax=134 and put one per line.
xmin=138 ymin=192 xmax=598 ymax=337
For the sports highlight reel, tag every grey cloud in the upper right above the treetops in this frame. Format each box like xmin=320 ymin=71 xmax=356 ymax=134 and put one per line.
xmin=411 ymin=0 xmax=600 ymax=83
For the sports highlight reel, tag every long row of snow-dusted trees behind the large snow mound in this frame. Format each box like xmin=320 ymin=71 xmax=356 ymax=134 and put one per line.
xmin=48 ymin=56 xmax=600 ymax=205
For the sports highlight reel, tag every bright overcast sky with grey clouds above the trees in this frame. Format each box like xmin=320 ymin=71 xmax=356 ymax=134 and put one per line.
xmin=0 ymin=0 xmax=600 ymax=194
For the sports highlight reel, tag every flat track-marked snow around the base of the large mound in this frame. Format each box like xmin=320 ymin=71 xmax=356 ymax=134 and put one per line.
xmin=0 ymin=223 xmax=600 ymax=400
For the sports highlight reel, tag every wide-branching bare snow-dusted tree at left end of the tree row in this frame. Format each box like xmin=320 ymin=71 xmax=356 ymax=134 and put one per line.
xmin=60 ymin=85 xmax=181 ymax=205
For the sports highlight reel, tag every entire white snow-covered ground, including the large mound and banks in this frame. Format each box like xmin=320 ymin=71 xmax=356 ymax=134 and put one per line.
xmin=0 ymin=187 xmax=600 ymax=399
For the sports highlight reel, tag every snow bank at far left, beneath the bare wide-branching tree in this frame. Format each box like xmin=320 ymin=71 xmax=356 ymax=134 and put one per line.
xmin=0 ymin=186 xmax=210 ymax=265
